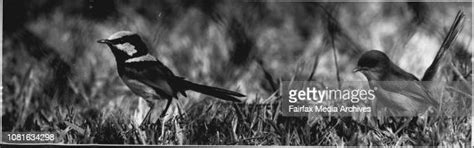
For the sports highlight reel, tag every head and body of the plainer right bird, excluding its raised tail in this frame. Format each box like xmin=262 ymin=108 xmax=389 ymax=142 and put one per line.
xmin=354 ymin=50 xmax=439 ymax=116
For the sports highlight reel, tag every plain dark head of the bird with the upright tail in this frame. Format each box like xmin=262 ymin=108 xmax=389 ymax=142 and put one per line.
xmin=354 ymin=50 xmax=391 ymax=80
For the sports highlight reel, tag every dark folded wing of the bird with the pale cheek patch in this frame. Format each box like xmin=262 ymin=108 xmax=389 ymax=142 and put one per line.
xmin=124 ymin=61 xmax=182 ymax=97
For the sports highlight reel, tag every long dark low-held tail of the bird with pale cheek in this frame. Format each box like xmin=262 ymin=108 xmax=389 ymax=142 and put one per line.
xmin=184 ymin=80 xmax=245 ymax=102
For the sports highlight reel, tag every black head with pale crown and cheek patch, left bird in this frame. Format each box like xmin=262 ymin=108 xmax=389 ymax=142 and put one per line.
xmin=97 ymin=31 xmax=152 ymax=61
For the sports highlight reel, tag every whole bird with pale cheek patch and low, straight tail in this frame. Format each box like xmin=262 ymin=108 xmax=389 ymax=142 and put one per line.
xmin=97 ymin=31 xmax=245 ymax=131
